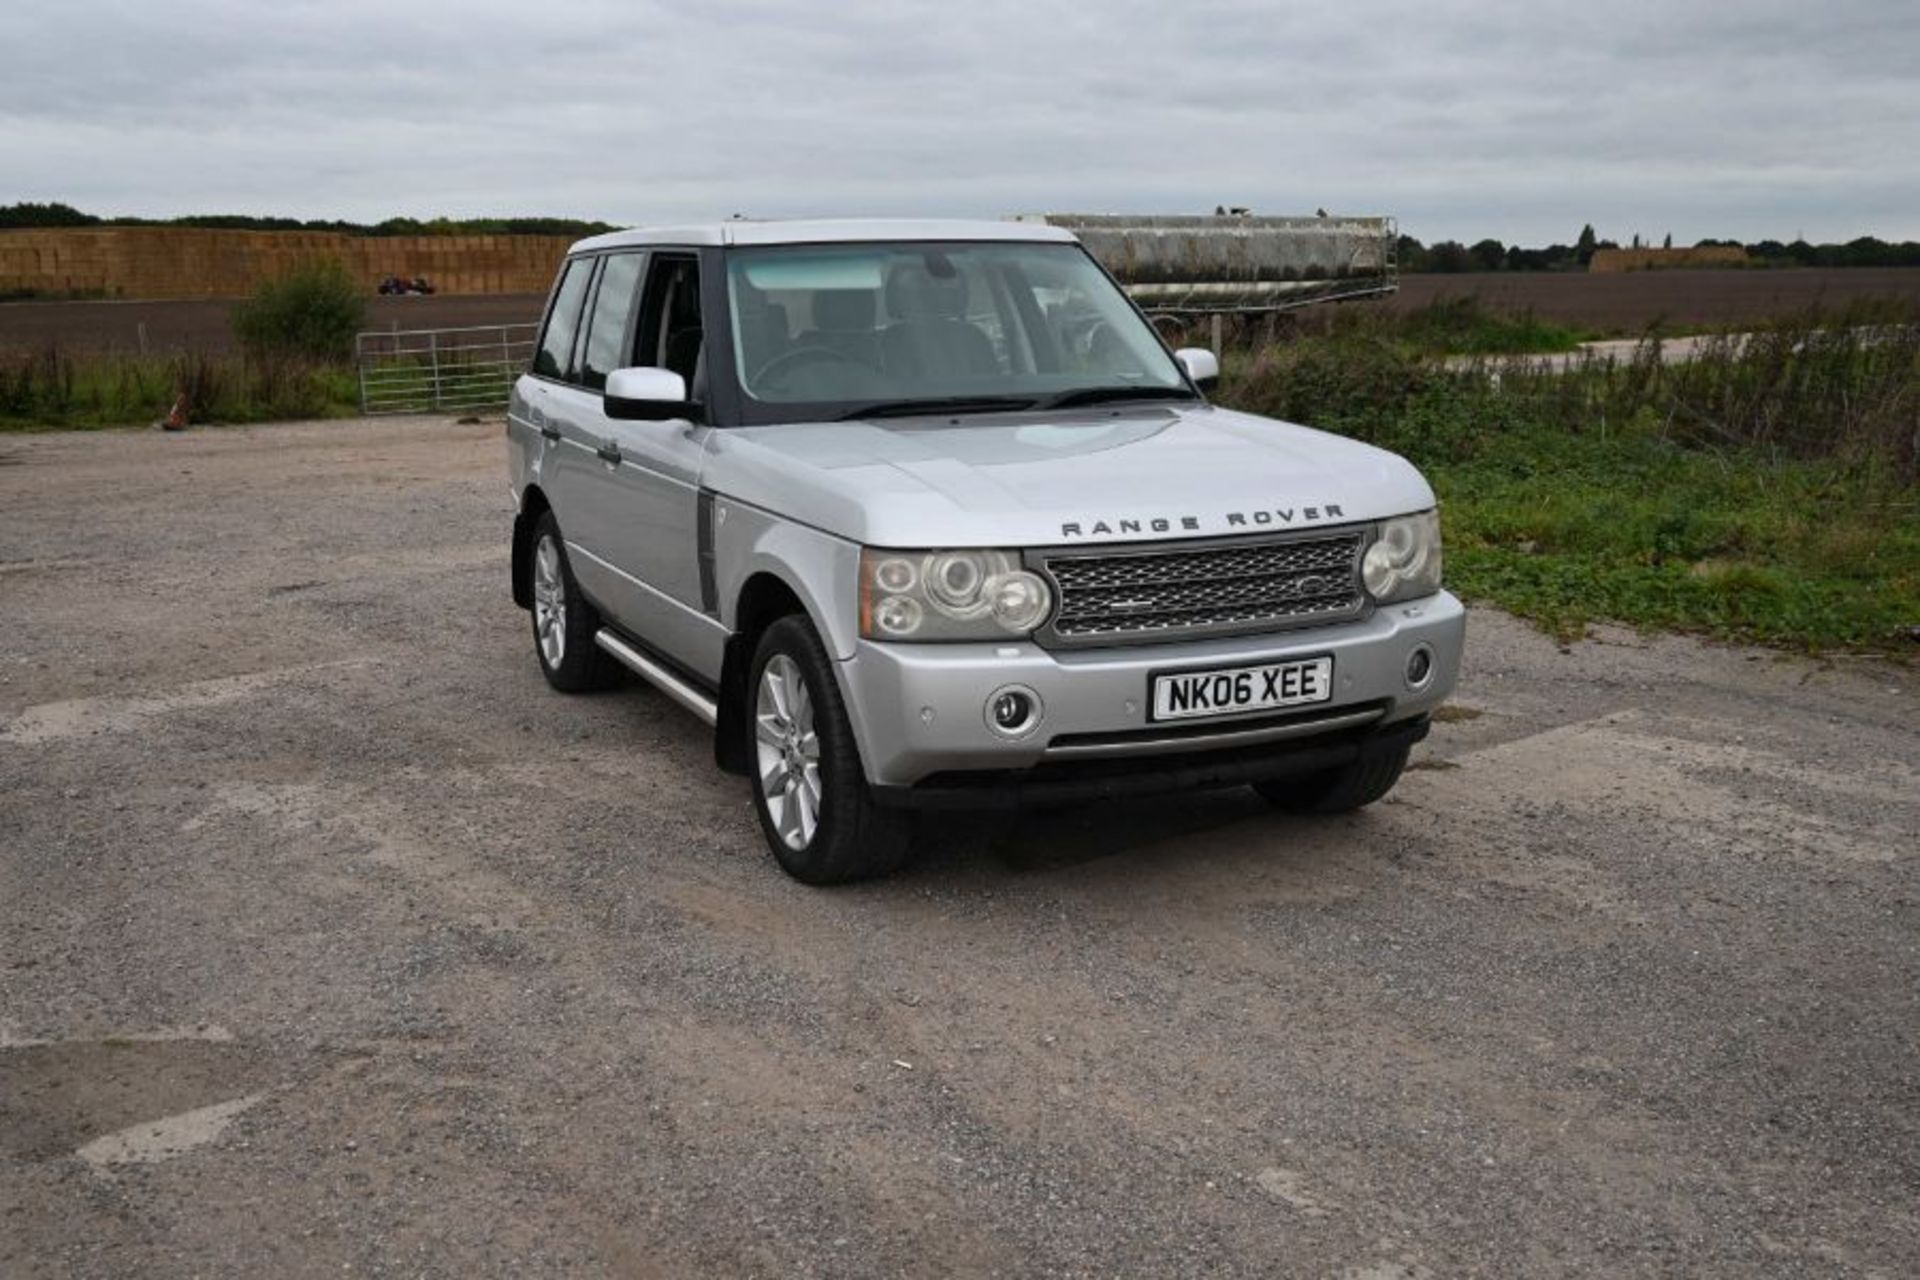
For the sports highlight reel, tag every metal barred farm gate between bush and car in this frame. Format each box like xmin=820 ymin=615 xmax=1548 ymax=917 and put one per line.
xmin=353 ymin=324 xmax=540 ymax=415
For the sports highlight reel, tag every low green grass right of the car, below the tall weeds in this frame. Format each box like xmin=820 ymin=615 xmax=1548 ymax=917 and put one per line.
xmin=1428 ymin=412 xmax=1920 ymax=652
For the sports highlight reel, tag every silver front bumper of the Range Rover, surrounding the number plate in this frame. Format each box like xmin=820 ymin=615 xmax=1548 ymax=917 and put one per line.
xmin=839 ymin=591 xmax=1467 ymax=793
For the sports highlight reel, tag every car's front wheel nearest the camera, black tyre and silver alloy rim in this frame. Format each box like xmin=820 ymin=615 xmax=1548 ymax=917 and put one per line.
xmin=741 ymin=614 xmax=908 ymax=885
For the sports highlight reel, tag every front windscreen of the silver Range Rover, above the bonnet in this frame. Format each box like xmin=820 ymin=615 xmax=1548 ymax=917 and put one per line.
xmin=728 ymin=244 xmax=1187 ymax=420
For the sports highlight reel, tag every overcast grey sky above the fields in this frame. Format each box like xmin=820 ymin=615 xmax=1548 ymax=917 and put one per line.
xmin=0 ymin=0 xmax=1920 ymax=244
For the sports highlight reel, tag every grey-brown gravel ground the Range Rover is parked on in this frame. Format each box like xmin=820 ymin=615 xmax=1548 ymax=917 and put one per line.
xmin=0 ymin=418 xmax=1920 ymax=1280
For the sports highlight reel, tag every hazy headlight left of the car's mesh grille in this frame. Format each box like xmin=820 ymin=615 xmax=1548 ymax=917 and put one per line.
xmin=860 ymin=547 xmax=1054 ymax=641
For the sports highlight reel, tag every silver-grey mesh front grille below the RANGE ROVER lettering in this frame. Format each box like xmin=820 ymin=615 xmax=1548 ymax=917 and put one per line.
xmin=1037 ymin=530 xmax=1367 ymax=645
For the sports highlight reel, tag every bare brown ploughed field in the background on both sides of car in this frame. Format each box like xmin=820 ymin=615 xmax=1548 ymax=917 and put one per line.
xmin=11 ymin=267 xmax=1920 ymax=351
